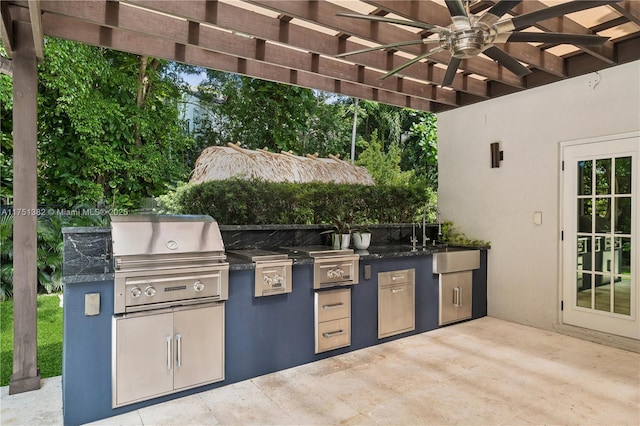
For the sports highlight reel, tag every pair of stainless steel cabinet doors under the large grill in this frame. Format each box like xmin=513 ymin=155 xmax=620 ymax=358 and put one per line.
xmin=112 ymin=303 xmax=224 ymax=408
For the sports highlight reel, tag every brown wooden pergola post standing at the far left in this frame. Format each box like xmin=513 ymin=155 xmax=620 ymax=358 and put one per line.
xmin=9 ymin=22 xmax=40 ymax=394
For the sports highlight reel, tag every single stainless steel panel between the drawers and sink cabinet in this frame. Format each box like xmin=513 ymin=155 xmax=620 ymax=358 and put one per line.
xmin=378 ymin=269 xmax=416 ymax=339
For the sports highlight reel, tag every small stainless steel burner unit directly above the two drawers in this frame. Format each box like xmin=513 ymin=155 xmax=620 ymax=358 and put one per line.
xmin=281 ymin=246 xmax=360 ymax=289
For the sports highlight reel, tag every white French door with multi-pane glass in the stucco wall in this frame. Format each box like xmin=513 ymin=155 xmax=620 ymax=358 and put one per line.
xmin=561 ymin=133 xmax=640 ymax=339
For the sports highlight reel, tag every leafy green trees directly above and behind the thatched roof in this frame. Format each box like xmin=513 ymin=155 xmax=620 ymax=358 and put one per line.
xmin=192 ymin=71 xmax=350 ymax=156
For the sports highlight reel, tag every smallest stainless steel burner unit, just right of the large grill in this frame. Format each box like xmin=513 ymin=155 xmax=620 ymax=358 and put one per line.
xmin=229 ymin=249 xmax=293 ymax=297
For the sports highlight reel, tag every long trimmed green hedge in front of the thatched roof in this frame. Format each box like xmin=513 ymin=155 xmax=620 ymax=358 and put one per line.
xmin=161 ymin=179 xmax=435 ymax=225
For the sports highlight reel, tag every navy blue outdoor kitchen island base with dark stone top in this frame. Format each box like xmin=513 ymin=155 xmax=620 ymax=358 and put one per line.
xmin=62 ymin=228 xmax=487 ymax=425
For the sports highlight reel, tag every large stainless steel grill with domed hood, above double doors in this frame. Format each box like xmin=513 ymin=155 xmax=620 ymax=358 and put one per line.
xmin=111 ymin=215 xmax=229 ymax=314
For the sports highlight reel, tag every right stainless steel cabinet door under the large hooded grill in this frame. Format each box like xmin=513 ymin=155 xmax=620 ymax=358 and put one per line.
xmin=173 ymin=304 xmax=224 ymax=390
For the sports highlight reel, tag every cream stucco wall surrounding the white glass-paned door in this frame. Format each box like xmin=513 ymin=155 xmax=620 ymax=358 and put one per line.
xmin=438 ymin=62 xmax=640 ymax=346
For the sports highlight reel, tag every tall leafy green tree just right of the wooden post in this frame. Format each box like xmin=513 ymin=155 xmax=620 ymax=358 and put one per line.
xmin=29 ymin=38 xmax=198 ymax=207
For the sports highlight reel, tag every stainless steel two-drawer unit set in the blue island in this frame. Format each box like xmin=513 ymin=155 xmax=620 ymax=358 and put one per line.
xmin=314 ymin=288 xmax=351 ymax=353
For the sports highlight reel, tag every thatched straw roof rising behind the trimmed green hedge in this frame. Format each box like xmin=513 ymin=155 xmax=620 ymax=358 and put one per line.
xmin=190 ymin=144 xmax=375 ymax=185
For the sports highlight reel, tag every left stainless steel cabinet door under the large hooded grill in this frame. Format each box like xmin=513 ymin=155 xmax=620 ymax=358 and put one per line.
xmin=113 ymin=313 xmax=173 ymax=406
